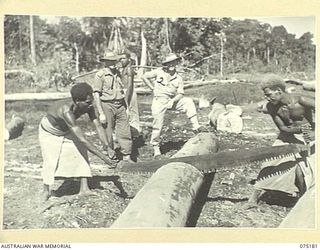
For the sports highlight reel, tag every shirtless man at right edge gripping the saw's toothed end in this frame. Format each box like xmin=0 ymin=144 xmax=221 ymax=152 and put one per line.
xmin=244 ymin=75 xmax=315 ymax=209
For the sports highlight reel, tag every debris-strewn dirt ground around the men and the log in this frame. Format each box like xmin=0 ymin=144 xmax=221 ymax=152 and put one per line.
xmin=3 ymin=84 xmax=312 ymax=229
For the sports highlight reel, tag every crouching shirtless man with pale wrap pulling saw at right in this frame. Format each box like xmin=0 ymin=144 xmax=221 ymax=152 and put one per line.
xmin=243 ymin=75 xmax=315 ymax=209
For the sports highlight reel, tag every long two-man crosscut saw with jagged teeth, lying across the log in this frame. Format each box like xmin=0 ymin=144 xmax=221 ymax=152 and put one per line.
xmin=118 ymin=144 xmax=309 ymax=173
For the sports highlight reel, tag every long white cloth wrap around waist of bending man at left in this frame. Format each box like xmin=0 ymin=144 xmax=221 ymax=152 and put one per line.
xmin=39 ymin=117 xmax=92 ymax=185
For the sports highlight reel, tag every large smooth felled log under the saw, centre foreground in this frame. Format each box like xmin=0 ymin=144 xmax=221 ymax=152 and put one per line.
xmin=112 ymin=133 xmax=218 ymax=228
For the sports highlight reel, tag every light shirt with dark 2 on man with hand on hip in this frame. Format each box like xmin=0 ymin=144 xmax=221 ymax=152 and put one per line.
xmin=152 ymin=69 xmax=184 ymax=97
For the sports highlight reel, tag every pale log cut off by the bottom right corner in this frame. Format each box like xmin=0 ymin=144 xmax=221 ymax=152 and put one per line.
xmin=279 ymin=186 xmax=316 ymax=229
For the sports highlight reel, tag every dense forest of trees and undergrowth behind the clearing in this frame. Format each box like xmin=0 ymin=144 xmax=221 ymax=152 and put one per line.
xmin=4 ymin=15 xmax=316 ymax=92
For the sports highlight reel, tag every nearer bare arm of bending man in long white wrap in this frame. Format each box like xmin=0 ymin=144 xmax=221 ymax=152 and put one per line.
xmin=62 ymin=108 xmax=112 ymax=164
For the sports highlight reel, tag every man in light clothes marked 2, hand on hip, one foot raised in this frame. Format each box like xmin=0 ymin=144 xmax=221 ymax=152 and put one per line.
xmin=141 ymin=54 xmax=204 ymax=157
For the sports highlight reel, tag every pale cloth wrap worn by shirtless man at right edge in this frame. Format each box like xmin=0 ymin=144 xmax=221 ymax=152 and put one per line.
xmin=254 ymin=134 xmax=315 ymax=194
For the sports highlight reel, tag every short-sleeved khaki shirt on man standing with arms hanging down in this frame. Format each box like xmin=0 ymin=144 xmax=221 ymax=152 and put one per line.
xmin=92 ymin=68 xmax=124 ymax=101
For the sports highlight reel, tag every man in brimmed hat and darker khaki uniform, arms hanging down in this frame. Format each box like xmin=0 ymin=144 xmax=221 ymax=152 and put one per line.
xmin=93 ymin=51 xmax=132 ymax=162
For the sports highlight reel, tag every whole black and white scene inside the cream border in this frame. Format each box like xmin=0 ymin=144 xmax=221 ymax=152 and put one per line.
xmin=1 ymin=12 xmax=318 ymax=231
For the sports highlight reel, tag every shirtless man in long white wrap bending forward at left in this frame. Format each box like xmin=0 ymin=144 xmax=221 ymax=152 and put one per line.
xmin=39 ymin=82 xmax=114 ymax=201
